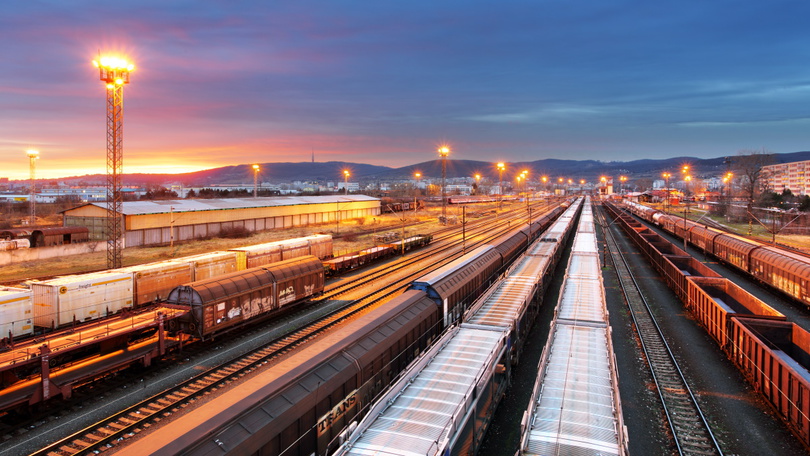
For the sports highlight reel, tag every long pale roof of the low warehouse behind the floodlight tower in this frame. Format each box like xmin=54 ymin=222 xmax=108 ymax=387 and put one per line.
xmin=76 ymin=195 xmax=379 ymax=215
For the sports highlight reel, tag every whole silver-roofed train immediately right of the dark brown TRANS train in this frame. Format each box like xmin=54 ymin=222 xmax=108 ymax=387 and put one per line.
xmin=336 ymin=203 xmax=598 ymax=456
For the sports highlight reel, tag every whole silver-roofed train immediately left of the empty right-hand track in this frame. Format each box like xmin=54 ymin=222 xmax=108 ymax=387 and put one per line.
xmin=519 ymin=201 xmax=627 ymax=455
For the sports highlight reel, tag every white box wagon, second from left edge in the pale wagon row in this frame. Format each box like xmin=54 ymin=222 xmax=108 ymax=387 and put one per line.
xmin=31 ymin=271 xmax=133 ymax=328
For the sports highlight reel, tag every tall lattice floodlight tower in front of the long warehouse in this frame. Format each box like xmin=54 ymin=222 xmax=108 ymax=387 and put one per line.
xmin=93 ymin=57 xmax=135 ymax=269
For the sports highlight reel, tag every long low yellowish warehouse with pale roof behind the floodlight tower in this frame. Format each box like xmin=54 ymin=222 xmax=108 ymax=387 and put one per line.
xmin=63 ymin=195 xmax=380 ymax=247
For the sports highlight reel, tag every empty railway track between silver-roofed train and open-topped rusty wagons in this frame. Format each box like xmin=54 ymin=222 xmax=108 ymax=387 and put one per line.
xmin=595 ymin=204 xmax=723 ymax=455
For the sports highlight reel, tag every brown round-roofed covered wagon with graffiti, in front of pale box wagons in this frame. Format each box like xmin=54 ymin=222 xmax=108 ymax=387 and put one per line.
xmin=166 ymin=256 xmax=324 ymax=339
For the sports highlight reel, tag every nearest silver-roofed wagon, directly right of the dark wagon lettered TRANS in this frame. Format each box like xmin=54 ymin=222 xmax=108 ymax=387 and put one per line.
xmin=335 ymin=323 xmax=507 ymax=456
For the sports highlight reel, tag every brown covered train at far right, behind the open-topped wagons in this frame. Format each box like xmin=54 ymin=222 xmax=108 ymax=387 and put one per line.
xmin=625 ymin=201 xmax=810 ymax=306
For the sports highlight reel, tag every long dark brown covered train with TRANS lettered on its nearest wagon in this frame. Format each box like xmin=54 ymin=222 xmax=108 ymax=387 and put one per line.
xmin=112 ymin=200 xmax=576 ymax=455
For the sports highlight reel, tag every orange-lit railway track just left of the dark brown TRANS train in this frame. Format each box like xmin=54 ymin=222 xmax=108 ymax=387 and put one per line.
xmin=26 ymin=201 xmax=556 ymax=455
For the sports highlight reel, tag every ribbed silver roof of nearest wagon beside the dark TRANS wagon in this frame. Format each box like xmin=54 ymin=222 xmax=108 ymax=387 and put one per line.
xmin=338 ymin=326 xmax=505 ymax=456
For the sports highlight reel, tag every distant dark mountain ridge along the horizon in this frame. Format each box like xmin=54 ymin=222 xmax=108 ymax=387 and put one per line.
xmin=51 ymin=151 xmax=810 ymax=187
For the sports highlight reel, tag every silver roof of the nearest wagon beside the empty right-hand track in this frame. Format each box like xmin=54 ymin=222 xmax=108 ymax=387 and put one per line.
xmin=521 ymin=325 xmax=619 ymax=455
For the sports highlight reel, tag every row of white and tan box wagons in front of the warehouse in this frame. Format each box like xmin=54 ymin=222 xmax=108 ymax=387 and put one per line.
xmin=0 ymin=234 xmax=332 ymax=346
